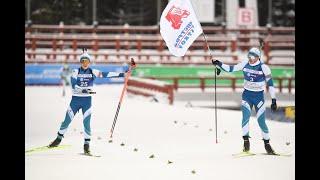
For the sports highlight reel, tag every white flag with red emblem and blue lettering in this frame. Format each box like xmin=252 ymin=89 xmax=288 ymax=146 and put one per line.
xmin=160 ymin=0 xmax=202 ymax=56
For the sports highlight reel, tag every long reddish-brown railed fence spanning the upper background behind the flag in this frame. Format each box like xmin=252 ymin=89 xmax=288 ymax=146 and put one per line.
xmin=25 ymin=25 xmax=295 ymax=66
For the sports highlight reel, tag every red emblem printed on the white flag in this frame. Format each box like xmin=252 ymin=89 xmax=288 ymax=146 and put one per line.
xmin=166 ymin=6 xmax=190 ymax=29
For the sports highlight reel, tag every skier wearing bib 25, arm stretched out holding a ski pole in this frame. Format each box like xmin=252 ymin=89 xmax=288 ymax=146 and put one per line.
xmin=49 ymin=51 xmax=135 ymax=154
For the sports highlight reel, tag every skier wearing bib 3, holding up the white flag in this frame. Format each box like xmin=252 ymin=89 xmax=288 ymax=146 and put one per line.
xmin=212 ymin=48 xmax=277 ymax=154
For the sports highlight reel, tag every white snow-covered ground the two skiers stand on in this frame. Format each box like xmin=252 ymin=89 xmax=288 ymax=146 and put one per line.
xmin=25 ymin=85 xmax=295 ymax=180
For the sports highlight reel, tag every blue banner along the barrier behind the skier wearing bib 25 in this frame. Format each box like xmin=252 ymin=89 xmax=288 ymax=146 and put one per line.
xmin=25 ymin=64 xmax=128 ymax=85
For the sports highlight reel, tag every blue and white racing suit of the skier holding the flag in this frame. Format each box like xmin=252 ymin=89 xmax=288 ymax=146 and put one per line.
xmin=219 ymin=59 xmax=276 ymax=140
